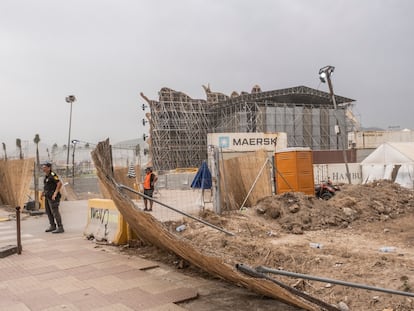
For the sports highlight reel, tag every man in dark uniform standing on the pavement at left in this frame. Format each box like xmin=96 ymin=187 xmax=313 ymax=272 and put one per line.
xmin=42 ymin=162 xmax=65 ymax=233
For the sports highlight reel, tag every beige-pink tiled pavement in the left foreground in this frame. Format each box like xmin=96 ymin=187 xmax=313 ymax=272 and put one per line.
xmin=0 ymin=204 xmax=197 ymax=311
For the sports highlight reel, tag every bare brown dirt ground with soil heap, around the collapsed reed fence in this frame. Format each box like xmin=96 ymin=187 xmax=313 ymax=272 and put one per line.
xmin=120 ymin=181 xmax=414 ymax=311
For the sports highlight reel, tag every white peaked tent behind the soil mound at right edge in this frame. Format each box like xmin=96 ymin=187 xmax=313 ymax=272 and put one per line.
xmin=361 ymin=142 xmax=414 ymax=189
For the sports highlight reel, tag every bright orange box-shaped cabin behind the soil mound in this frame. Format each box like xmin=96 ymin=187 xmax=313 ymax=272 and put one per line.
xmin=275 ymin=148 xmax=315 ymax=195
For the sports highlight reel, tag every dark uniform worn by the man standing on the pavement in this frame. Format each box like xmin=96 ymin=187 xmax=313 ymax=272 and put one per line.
xmin=43 ymin=171 xmax=63 ymax=231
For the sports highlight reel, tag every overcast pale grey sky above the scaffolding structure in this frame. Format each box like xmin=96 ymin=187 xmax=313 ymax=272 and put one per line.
xmin=0 ymin=0 xmax=414 ymax=149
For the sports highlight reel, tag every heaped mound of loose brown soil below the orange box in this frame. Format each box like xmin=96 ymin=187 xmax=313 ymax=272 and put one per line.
xmin=255 ymin=181 xmax=414 ymax=234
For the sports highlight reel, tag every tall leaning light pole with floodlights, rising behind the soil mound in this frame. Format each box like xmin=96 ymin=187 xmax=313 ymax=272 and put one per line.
xmin=319 ymin=66 xmax=351 ymax=184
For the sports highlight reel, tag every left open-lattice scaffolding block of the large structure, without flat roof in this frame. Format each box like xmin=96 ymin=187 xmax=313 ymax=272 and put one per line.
xmin=144 ymin=88 xmax=209 ymax=170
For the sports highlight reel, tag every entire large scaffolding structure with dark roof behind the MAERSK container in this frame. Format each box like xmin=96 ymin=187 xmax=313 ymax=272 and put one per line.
xmin=142 ymin=85 xmax=354 ymax=170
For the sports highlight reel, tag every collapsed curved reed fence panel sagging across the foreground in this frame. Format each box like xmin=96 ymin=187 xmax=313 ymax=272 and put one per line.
xmin=92 ymin=140 xmax=317 ymax=310
